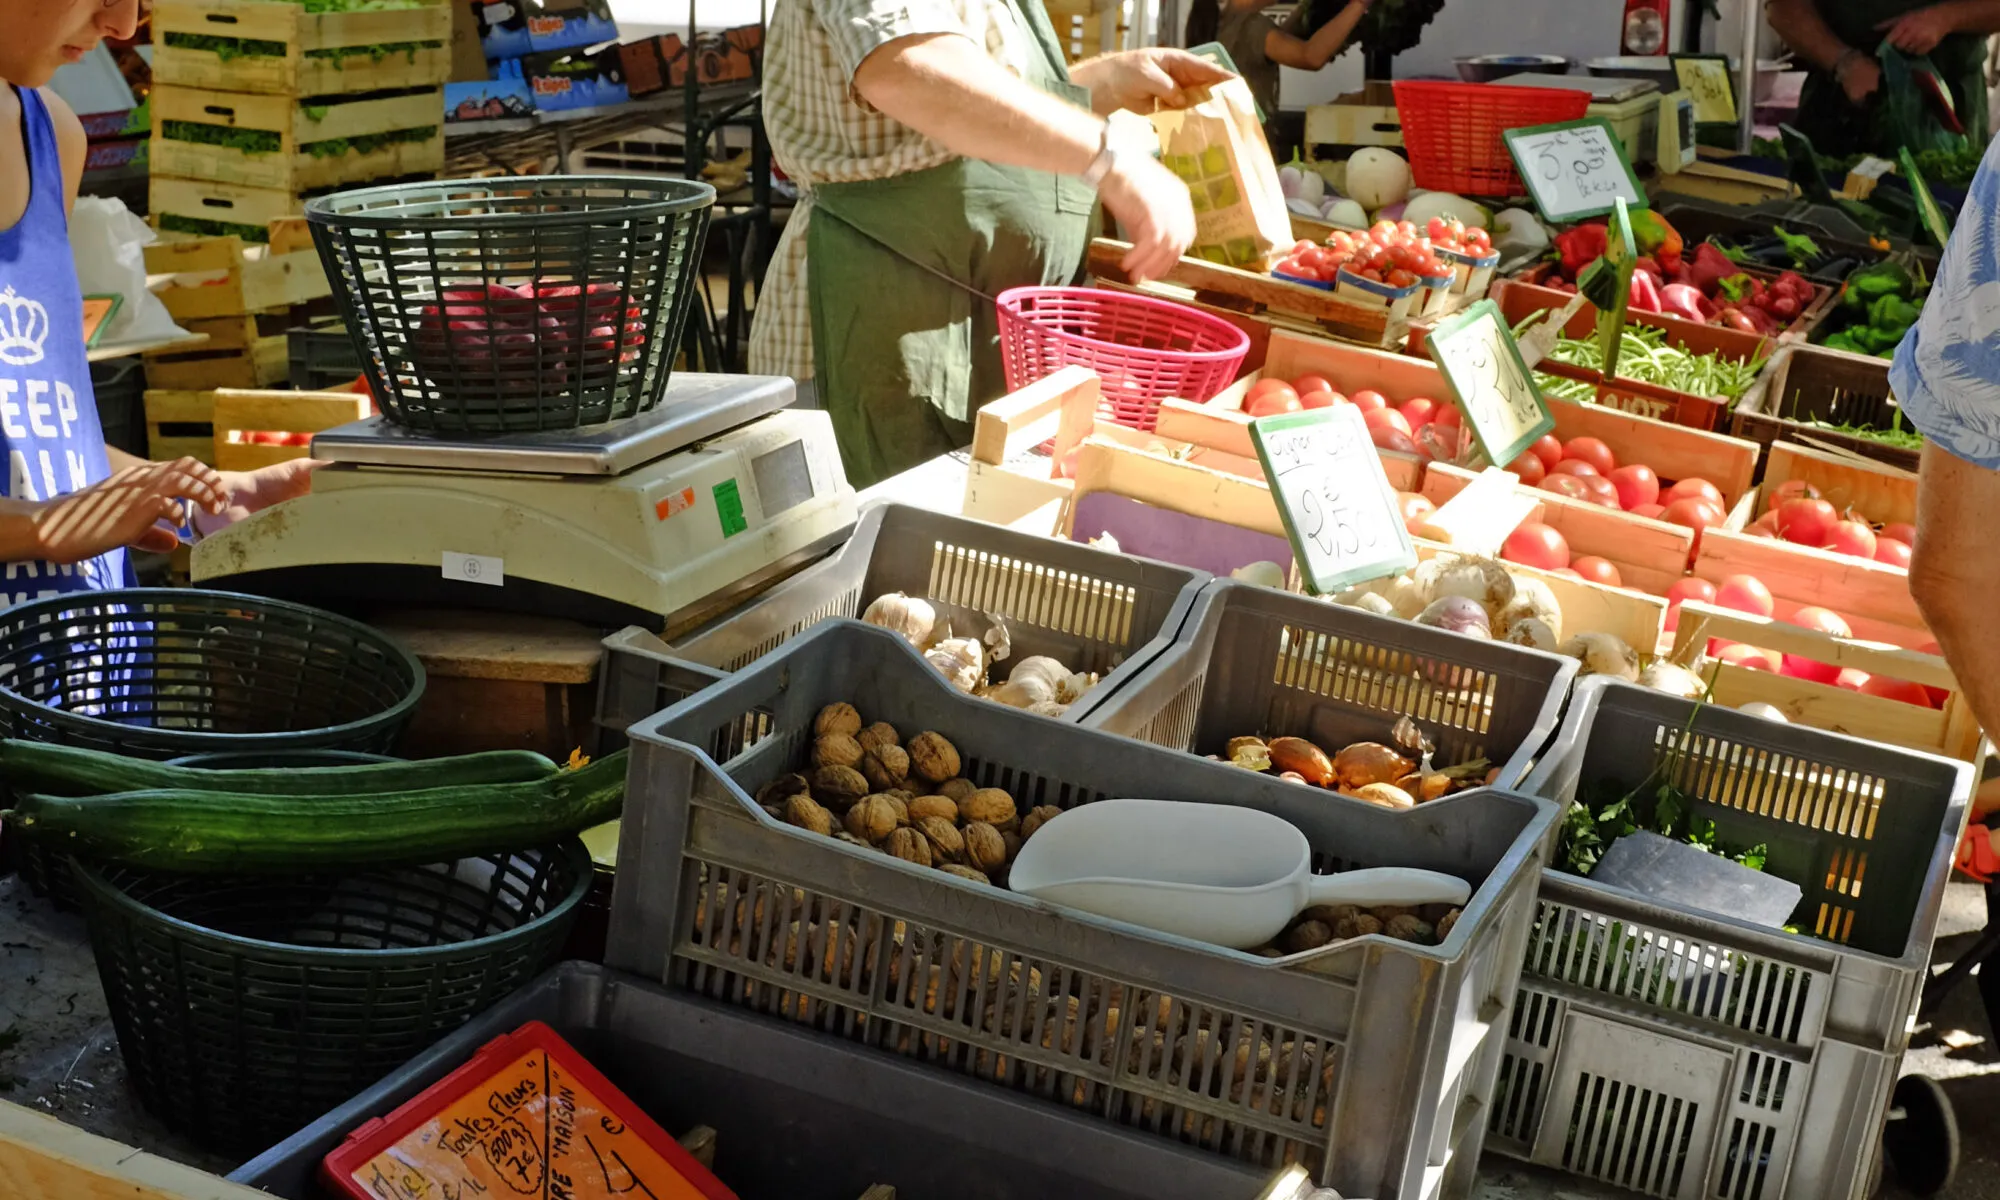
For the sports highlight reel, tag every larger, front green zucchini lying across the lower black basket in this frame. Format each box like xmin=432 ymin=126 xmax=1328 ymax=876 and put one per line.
xmin=12 ymin=750 xmax=626 ymax=874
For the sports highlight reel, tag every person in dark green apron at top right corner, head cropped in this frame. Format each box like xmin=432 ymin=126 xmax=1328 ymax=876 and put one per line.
xmin=1764 ymin=0 xmax=2000 ymax=158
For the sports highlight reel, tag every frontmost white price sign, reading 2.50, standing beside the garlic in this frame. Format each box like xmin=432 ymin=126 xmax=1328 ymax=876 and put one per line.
xmin=1250 ymin=404 xmax=1416 ymax=596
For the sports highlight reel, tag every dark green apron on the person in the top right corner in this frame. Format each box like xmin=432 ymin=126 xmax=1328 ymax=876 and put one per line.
xmin=1798 ymin=0 xmax=1986 ymax=158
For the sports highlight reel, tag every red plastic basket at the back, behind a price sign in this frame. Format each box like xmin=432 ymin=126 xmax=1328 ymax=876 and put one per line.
xmin=1396 ymin=80 xmax=1590 ymax=196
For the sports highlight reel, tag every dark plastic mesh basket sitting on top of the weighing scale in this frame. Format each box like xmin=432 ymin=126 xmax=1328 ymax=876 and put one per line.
xmin=306 ymin=176 xmax=716 ymax=434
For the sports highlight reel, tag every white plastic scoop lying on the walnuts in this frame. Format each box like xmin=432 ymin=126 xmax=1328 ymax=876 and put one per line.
xmin=1008 ymin=800 xmax=1472 ymax=950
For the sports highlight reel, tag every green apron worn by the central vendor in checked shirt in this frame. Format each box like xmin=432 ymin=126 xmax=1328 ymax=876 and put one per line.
xmin=806 ymin=0 xmax=1098 ymax=488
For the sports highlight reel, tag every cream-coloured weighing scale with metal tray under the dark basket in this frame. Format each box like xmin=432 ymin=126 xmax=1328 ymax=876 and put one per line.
xmin=192 ymin=374 xmax=854 ymax=630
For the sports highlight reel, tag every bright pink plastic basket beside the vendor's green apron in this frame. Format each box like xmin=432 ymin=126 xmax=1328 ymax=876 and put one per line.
xmin=1000 ymin=288 xmax=1250 ymax=432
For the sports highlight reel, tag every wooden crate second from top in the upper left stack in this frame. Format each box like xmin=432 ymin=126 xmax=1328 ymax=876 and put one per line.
xmin=152 ymin=86 xmax=444 ymax=193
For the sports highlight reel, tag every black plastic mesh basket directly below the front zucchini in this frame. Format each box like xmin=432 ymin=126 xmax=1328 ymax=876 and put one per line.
xmin=70 ymin=838 xmax=590 ymax=1156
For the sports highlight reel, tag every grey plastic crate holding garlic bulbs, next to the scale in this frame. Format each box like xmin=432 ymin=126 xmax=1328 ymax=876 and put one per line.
xmin=598 ymin=502 xmax=1210 ymax=732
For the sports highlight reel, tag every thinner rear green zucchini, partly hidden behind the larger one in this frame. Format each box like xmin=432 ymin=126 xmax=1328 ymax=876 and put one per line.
xmin=0 ymin=740 xmax=558 ymax=796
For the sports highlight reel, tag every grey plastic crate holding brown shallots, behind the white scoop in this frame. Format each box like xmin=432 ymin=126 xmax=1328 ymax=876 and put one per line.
xmin=1088 ymin=580 xmax=1578 ymax=786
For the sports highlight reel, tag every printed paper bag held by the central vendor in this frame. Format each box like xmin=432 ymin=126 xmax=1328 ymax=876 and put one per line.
xmin=1152 ymin=78 xmax=1294 ymax=274
